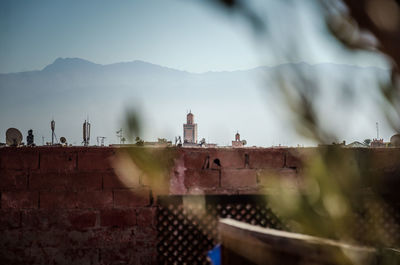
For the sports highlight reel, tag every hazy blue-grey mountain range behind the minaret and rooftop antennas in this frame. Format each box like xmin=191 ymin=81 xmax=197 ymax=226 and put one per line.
xmin=0 ymin=58 xmax=392 ymax=146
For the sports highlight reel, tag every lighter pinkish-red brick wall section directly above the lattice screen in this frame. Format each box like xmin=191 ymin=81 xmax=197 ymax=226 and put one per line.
xmin=170 ymin=148 xmax=297 ymax=194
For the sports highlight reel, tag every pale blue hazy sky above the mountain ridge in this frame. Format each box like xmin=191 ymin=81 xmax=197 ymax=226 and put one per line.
xmin=0 ymin=0 xmax=383 ymax=73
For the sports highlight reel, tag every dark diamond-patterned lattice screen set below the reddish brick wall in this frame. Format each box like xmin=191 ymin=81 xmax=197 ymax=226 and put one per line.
xmin=157 ymin=195 xmax=283 ymax=264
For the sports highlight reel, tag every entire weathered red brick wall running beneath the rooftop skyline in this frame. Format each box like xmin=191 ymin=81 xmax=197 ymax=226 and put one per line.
xmin=0 ymin=147 xmax=400 ymax=264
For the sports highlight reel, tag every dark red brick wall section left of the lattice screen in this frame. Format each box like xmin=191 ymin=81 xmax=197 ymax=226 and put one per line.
xmin=0 ymin=147 xmax=156 ymax=264
